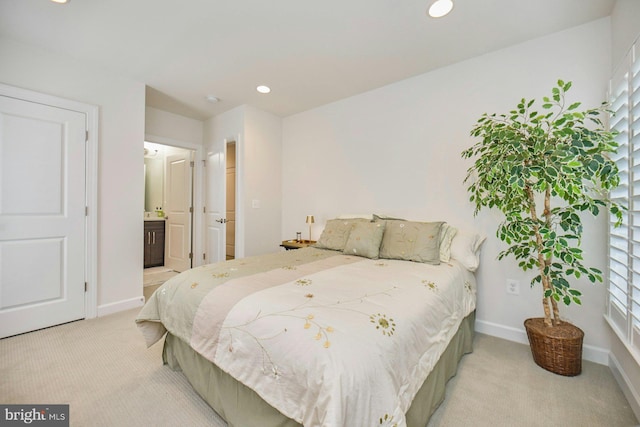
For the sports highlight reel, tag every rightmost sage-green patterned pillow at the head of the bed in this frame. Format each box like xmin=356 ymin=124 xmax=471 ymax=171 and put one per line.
xmin=380 ymin=220 xmax=444 ymax=264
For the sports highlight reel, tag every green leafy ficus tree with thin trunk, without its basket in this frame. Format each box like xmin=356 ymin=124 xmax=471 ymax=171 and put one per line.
xmin=462 ymin=80 xmax=623 ymax=326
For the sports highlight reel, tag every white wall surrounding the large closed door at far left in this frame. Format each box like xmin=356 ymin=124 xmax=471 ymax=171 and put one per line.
xmin=0 ymin=38 xmax=145 ymax=315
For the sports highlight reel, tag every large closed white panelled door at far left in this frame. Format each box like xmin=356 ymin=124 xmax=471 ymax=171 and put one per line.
xmin=0 ymin=96 xmax=86 ymax=338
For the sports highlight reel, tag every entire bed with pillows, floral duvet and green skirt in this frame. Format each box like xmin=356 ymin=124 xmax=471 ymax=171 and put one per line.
xmin=136 ymin=218 xmax=481 ymax=427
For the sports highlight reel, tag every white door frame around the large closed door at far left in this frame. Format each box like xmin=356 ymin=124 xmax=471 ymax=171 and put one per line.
xmin=0 ymin=83 xmax=99 ymax=319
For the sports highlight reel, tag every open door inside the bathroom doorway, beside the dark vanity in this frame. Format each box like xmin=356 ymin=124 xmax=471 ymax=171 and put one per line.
xmin=164 ymin=150 xmax=193 ymax=271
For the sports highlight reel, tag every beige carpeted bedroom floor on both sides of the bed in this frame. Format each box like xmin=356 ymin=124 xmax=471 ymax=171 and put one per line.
xmin=0 ymin=310 xmax=638 ymax=427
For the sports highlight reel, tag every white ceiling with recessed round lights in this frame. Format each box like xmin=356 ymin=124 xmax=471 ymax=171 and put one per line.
xmin=0 ymin=0 xmax=615 ymax=119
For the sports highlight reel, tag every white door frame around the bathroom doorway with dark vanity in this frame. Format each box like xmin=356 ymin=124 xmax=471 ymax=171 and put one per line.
xmin=142 ymin=133 xmax=204 ymax=268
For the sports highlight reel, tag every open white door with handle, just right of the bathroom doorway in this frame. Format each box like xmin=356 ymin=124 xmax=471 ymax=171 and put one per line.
xmin=205 ymin=140 xmax=227 ymax=263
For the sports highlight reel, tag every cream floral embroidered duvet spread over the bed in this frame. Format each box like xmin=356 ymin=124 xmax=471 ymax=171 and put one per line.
xmin=136 ymin=248 xmax=476 ymax=427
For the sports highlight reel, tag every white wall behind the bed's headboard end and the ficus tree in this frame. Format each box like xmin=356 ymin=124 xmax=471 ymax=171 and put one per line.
xmin=282 ymin=18 xmax=611 ymax=363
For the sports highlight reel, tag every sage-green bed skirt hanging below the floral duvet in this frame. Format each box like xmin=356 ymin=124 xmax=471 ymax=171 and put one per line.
xmin=162 ymin=312 xmax=475 ymax=427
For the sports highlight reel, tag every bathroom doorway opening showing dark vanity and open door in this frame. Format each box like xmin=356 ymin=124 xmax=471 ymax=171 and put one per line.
xmin=144 ymin=141 xmax=195 ymax=295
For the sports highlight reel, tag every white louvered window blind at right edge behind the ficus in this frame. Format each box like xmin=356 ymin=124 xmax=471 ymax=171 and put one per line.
xmin=607 ymin=41 xmax=640 ymax=363
